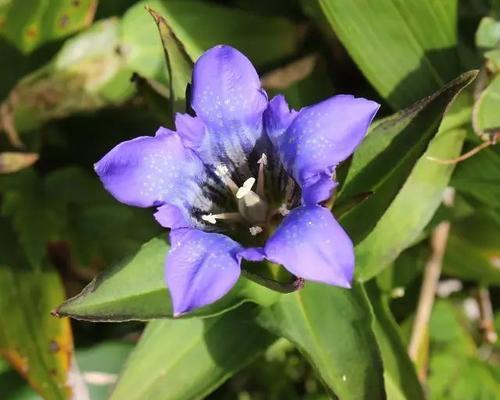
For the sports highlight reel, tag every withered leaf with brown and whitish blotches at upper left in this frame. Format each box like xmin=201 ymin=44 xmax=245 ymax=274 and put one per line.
xmin=3 ymin=18 xmax=134 ymax=132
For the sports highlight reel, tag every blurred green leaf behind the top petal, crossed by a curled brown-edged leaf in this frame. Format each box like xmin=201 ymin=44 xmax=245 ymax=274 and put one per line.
xmin=122 ymin=0 xmax=299 ymax=82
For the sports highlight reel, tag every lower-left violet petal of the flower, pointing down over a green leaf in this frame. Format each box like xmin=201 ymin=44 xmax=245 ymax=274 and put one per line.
xmin=165 ymin=229 xmax=241 ymax=316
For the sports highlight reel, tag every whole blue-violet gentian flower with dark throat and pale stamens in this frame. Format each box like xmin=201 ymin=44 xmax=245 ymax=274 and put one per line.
xmin=95 ymin=45 xmax=379 ymax=315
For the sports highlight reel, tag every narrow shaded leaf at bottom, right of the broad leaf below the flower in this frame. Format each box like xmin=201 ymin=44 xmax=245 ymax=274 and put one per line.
xmin=364 ymin=280 xmax=424 ymax=400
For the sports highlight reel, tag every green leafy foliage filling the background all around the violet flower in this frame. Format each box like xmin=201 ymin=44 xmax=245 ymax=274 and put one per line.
xmin=0 ymin=0 xmax=500 ymax=400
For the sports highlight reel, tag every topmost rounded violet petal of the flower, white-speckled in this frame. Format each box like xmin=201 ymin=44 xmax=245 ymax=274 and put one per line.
xmin=191 ymin=45 xmax=267 ymax=165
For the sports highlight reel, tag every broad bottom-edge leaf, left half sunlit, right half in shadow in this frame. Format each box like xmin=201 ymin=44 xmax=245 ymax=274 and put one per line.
xmin=110 ymin=304 xmax=275 ymax=400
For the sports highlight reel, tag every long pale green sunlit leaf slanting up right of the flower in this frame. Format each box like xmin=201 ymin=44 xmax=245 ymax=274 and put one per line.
xmin=356 ymin=80 xmax=471 ymax=281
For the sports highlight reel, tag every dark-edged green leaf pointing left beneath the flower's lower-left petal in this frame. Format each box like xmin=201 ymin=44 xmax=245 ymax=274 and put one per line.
xmin=55 ymin=238 xmax=279 ymax=322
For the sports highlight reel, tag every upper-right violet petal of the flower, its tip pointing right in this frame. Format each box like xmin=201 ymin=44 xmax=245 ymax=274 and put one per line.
xmin=277 ymin=95 xmax=379 ymax=204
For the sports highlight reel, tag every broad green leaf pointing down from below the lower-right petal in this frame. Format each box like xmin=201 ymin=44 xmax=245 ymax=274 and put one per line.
xmin=260 ymin=282 xmax=385 ymax=400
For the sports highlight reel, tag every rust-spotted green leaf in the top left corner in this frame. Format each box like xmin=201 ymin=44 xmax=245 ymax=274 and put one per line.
xmin=0 ymin=0 xmax=97 ymax=53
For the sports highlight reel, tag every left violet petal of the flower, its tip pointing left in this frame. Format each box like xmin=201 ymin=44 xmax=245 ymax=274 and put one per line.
xmin=95 ymin=128 xmax=206 ymax=227
